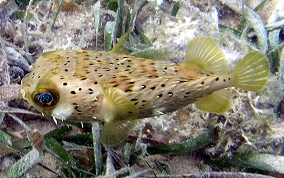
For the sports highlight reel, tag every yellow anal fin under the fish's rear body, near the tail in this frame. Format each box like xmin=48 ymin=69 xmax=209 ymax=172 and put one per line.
xmin=195 ymin=89 xmax=232 ymax=113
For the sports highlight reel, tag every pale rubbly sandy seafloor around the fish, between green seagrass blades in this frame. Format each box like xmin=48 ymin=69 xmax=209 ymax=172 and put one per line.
xmin=0 ymin=0 xmax=284 ymax=177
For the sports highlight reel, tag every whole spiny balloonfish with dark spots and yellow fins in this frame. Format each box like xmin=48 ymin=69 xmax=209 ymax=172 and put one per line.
xmin=22 ymin=37 xmax=270 ymax=145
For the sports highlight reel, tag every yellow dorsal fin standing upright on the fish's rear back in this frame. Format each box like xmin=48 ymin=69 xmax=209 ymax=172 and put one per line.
xmin=184 ymin=37 xmax=229 ymax=74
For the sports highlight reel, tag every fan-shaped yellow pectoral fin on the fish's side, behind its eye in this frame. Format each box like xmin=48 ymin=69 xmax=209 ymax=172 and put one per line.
xmin=101 ymin=84 xmax=138 ymax=146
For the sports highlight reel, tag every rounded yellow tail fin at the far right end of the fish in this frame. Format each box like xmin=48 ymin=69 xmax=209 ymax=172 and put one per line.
xmin=232 ymin=51 xmax=269 ymax=92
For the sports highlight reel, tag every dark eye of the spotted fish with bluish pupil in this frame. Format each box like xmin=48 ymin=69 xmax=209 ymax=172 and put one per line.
xmin=33 ymin=90 xmax=59 ymax=108
